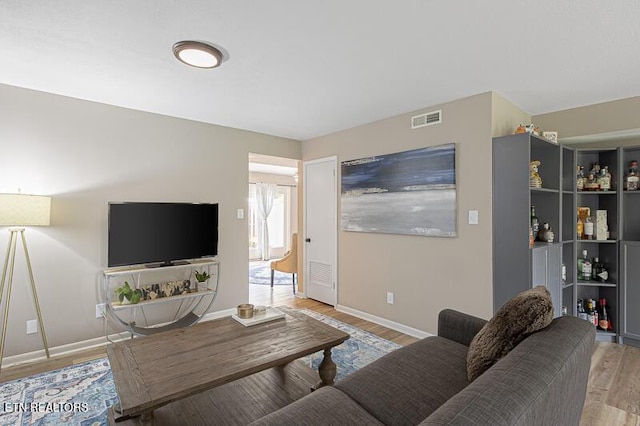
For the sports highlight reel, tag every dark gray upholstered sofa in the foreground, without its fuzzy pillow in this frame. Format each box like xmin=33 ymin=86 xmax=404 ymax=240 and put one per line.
xmin=252 ymin=310 xmax=595 ymax=426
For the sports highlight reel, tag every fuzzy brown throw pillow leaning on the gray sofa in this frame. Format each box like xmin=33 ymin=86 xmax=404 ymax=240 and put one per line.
xmin=467 ymin=286 xmax=553 ymax=381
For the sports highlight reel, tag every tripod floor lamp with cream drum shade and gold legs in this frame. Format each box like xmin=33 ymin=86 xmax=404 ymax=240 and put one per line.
xmin=0 ymin=194 xmax=51 ymax=368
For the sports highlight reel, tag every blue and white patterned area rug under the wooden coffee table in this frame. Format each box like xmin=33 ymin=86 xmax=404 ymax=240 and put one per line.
xmin=0 ymin=310 xmax=400 ymax=426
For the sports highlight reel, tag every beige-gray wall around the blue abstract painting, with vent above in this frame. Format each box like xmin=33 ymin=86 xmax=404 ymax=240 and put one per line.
xmin=302 ymin=93 xmax=492 ymax=333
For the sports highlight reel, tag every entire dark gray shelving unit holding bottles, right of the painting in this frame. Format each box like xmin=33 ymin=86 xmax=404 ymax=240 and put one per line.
xmin=492 ymin=138 xmax=640 ymax=347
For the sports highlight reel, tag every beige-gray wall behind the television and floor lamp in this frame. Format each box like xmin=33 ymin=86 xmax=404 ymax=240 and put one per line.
xmin=0 ymin=85 xmax=301 ymax=356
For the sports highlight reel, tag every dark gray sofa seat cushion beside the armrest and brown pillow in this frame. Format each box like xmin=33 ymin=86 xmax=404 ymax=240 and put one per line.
xmin=335 ymin=337 xmax=469 ymax=425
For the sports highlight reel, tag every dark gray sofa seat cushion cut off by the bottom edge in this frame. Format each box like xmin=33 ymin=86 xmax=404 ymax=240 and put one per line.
xmin=250 ymin=386 xmax=382 ymax=426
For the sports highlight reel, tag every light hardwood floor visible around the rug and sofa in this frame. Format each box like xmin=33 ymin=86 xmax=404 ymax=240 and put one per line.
xmin=0 ymin=285 xmax=640 ymax=426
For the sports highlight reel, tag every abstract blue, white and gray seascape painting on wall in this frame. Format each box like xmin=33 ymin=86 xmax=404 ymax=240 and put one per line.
xmin=341 ymin=143 xmax=457 ymax=237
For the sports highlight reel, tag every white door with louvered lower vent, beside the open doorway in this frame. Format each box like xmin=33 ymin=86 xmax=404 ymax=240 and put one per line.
xmin=303 ymin=157 xmax=338 ymax=306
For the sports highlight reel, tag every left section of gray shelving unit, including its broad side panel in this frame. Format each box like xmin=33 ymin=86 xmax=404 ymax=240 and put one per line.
xmin=492 ymin=133 xmax=564 ymax=316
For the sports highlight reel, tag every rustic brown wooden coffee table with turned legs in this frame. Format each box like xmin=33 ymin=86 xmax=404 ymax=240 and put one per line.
xmin=107 ymin=307 xmax=349 ymax=424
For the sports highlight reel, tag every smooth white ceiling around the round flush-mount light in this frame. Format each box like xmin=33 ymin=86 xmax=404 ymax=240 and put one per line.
xmin=0 ymin=0 xmax=640 ymax=140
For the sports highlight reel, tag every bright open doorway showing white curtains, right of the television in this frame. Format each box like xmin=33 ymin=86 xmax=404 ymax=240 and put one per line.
xmin=247 ymin=153 xmax=300 ymax=305
